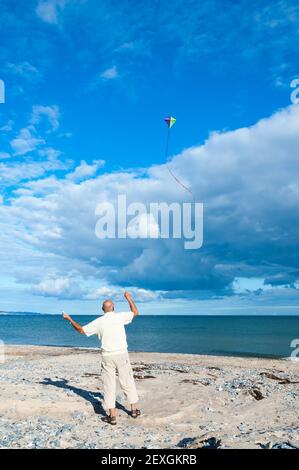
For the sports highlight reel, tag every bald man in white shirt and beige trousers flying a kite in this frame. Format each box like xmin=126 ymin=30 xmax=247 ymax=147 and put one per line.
xmin=63 ymin=292 xmax=140 ymax=425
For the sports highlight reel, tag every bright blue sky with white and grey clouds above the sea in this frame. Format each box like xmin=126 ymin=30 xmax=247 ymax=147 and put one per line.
xmin=0 ymin=0 xmax=299 ymax=314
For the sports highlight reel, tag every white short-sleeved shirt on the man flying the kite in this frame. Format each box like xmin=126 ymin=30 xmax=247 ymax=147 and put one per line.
xmin=83 ymin=312 xmax=134 ymax=355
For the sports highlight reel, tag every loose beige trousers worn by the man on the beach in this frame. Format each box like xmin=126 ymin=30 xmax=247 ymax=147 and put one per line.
xmin=102 ymin=352 xmax=138 ymax=411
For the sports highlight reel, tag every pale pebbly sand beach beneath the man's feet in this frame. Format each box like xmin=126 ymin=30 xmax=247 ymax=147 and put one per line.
xmin=0 ymin=346 xmax=299 ymax=449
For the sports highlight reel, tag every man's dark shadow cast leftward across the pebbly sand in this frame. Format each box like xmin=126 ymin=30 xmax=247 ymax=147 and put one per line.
xmin=39 ymin=377 xmax=129 ymax=416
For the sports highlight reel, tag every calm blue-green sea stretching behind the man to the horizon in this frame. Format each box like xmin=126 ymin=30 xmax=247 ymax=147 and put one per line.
xmin=0 ymin=315 xmax=299 ymax=357
